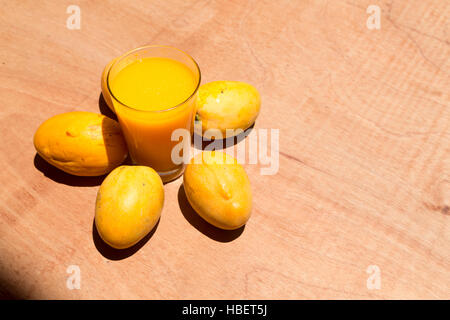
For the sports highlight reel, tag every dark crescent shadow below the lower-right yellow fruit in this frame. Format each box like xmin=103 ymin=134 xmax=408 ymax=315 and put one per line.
xmin=178 ymin=185 xmax=245 ymax=242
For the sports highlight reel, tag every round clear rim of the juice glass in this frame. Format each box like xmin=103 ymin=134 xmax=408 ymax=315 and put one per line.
xmin=106 ymin=45 xmax=202 ymax=113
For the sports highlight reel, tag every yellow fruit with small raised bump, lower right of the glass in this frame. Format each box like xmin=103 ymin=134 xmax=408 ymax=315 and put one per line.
xmin=183 ymin=151 xmax=252 ymax=230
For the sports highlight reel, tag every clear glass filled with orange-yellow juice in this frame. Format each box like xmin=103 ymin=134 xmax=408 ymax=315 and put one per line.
xmin=107 ymin=46 xmax=201 ymax=182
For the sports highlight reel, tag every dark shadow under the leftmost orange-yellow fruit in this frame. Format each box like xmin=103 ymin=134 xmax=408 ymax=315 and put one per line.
xmin=33 ymin=153 xmax=106 ymax=187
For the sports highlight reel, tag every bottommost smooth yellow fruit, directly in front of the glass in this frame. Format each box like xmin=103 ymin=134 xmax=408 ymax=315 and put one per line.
xmin=95 ymin=166 xmax=164 ymax=249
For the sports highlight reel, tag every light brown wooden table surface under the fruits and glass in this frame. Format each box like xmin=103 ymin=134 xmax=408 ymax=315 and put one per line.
xmin=0 ymin=0 xmax=450 ymax=299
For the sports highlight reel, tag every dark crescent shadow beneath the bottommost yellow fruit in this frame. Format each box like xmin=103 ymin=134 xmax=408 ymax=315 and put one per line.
xmin=92 ymin=220 xmax=159 ymax=260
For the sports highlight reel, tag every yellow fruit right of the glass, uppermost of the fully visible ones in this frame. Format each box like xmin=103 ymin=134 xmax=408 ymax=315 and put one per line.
xmin=196 ymin=81 xmax=261 ymax=139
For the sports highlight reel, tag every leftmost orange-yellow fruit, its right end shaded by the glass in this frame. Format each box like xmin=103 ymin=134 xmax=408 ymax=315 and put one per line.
xmin=34 ymin=111 xmax=128 ymax=176
